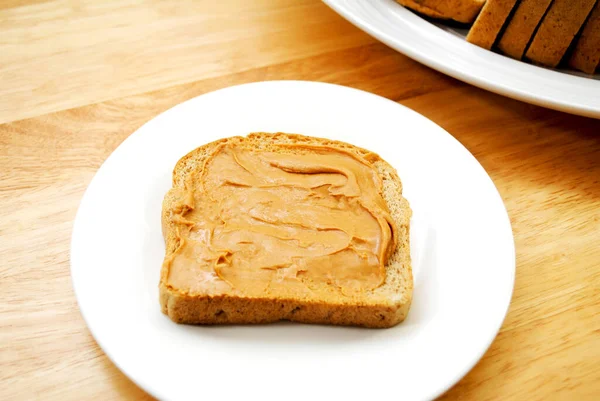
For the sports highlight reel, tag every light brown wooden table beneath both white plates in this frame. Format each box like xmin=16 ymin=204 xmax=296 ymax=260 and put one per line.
xmin=0 ymin=0 xmax=600 ymax=400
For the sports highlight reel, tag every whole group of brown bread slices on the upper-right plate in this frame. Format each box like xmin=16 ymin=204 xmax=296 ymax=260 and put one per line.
xmin=398 ymin=0 xmax=600 ymax=74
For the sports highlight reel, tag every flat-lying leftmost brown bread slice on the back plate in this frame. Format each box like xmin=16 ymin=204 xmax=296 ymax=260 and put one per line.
xmin=396 ymin=0 xmax=485 ymax=24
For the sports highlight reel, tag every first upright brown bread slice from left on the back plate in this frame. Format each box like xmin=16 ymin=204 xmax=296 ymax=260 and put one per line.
xmin=467 ymin=0 xmax=518 ymax=50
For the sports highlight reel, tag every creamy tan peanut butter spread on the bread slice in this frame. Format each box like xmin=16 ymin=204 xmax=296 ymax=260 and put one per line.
xmin=165 ymin=143 xmax=396 ymax=296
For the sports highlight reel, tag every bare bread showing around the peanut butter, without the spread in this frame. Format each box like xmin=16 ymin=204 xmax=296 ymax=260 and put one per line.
xmin=159 ymin=133 xmax=413 ymax=327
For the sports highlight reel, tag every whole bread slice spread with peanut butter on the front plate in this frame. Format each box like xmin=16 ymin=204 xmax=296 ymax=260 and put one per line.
xmin=159 ymin=133 xmax=413 ymax=327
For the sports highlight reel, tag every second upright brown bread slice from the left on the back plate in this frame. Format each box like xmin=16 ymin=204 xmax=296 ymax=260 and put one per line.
xmin=498 ymin=0 xmax=552 ymax=60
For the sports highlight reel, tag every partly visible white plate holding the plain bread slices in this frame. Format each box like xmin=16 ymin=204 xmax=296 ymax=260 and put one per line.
xmin=323 ymin=0 xmax=600 ymax=118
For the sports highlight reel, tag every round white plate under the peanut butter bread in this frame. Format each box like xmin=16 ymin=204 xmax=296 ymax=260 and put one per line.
xmin=71 ymin=81 xmax=515 ymax=401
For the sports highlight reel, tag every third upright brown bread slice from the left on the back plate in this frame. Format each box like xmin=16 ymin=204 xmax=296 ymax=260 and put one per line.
xmin=525 ymin=0 xmax=596 ymax=67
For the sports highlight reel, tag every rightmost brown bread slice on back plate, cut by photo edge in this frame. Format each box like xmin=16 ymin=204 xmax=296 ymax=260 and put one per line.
xmin=569 ymin=2 xmax=600 ymax=74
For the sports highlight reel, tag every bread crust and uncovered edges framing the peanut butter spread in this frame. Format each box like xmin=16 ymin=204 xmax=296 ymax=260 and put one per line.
xmin=159 ymin=133 xmax=413 ymax=328
